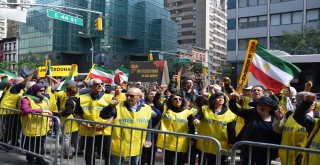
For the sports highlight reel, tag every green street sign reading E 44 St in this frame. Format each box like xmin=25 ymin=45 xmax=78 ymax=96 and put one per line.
xmin=47 ymin=9 xmax=83 ymax=26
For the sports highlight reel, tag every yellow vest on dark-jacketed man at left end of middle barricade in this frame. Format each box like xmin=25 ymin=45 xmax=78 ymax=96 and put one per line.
xmin=80 ymin=93 xmax=113 ymax=136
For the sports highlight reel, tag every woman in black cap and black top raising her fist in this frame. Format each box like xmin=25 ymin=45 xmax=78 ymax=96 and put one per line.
xmin=229 ymin=93 xmax=281 ymax=164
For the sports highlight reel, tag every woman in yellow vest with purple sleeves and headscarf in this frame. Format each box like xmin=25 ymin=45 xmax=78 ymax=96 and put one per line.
xmin=21 ymin=84 xmax=52 ymax=165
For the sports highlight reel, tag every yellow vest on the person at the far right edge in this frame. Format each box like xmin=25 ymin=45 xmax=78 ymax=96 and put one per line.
xmin=302 ymin=119 xmax=320 ymax=164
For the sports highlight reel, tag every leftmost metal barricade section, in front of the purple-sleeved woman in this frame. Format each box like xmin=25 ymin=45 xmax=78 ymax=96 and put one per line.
xmin=0 ymin=107 xmax=60 ymax=164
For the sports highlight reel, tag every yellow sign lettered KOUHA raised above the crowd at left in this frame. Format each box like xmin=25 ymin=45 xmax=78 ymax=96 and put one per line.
xmin=38 ymin=65 xmax=78 ymax=77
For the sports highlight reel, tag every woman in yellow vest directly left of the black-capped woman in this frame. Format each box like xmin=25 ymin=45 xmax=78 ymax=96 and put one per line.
xmin=193 ymin=92 xmax=236 ymax=164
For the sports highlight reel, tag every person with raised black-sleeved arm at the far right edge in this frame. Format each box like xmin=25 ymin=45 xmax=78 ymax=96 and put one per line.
xmin=293 ymin=93 xmax=320 ymax=164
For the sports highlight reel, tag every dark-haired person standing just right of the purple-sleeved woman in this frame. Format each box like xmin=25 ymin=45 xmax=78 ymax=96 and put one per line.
xmin=59 ymin=85 xmax=79 ymax=159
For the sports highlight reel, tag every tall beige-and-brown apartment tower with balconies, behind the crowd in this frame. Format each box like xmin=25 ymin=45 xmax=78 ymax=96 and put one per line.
xmin=164 ymin=0 xmax=227 ymax=79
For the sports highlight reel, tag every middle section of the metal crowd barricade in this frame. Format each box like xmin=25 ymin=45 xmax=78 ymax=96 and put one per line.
xmin=60 ymin=118 xmax=221 ymax=165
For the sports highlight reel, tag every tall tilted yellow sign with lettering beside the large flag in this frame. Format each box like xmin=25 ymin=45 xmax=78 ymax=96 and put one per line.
xmin=237 ymin=40 xmax=258 ymax=93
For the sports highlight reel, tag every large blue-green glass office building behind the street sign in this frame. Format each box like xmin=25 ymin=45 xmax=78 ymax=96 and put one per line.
xmin=19 ymin=0 xmax=177 ymax=72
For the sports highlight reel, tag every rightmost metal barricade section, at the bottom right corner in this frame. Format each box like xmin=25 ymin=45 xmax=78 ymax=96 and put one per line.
xmin=231 ymin=141 xmax=320 ymax=165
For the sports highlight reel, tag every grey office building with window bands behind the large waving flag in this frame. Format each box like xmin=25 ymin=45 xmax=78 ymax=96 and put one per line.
xmin=228 ymin=0 xmax=320 ymax=82
